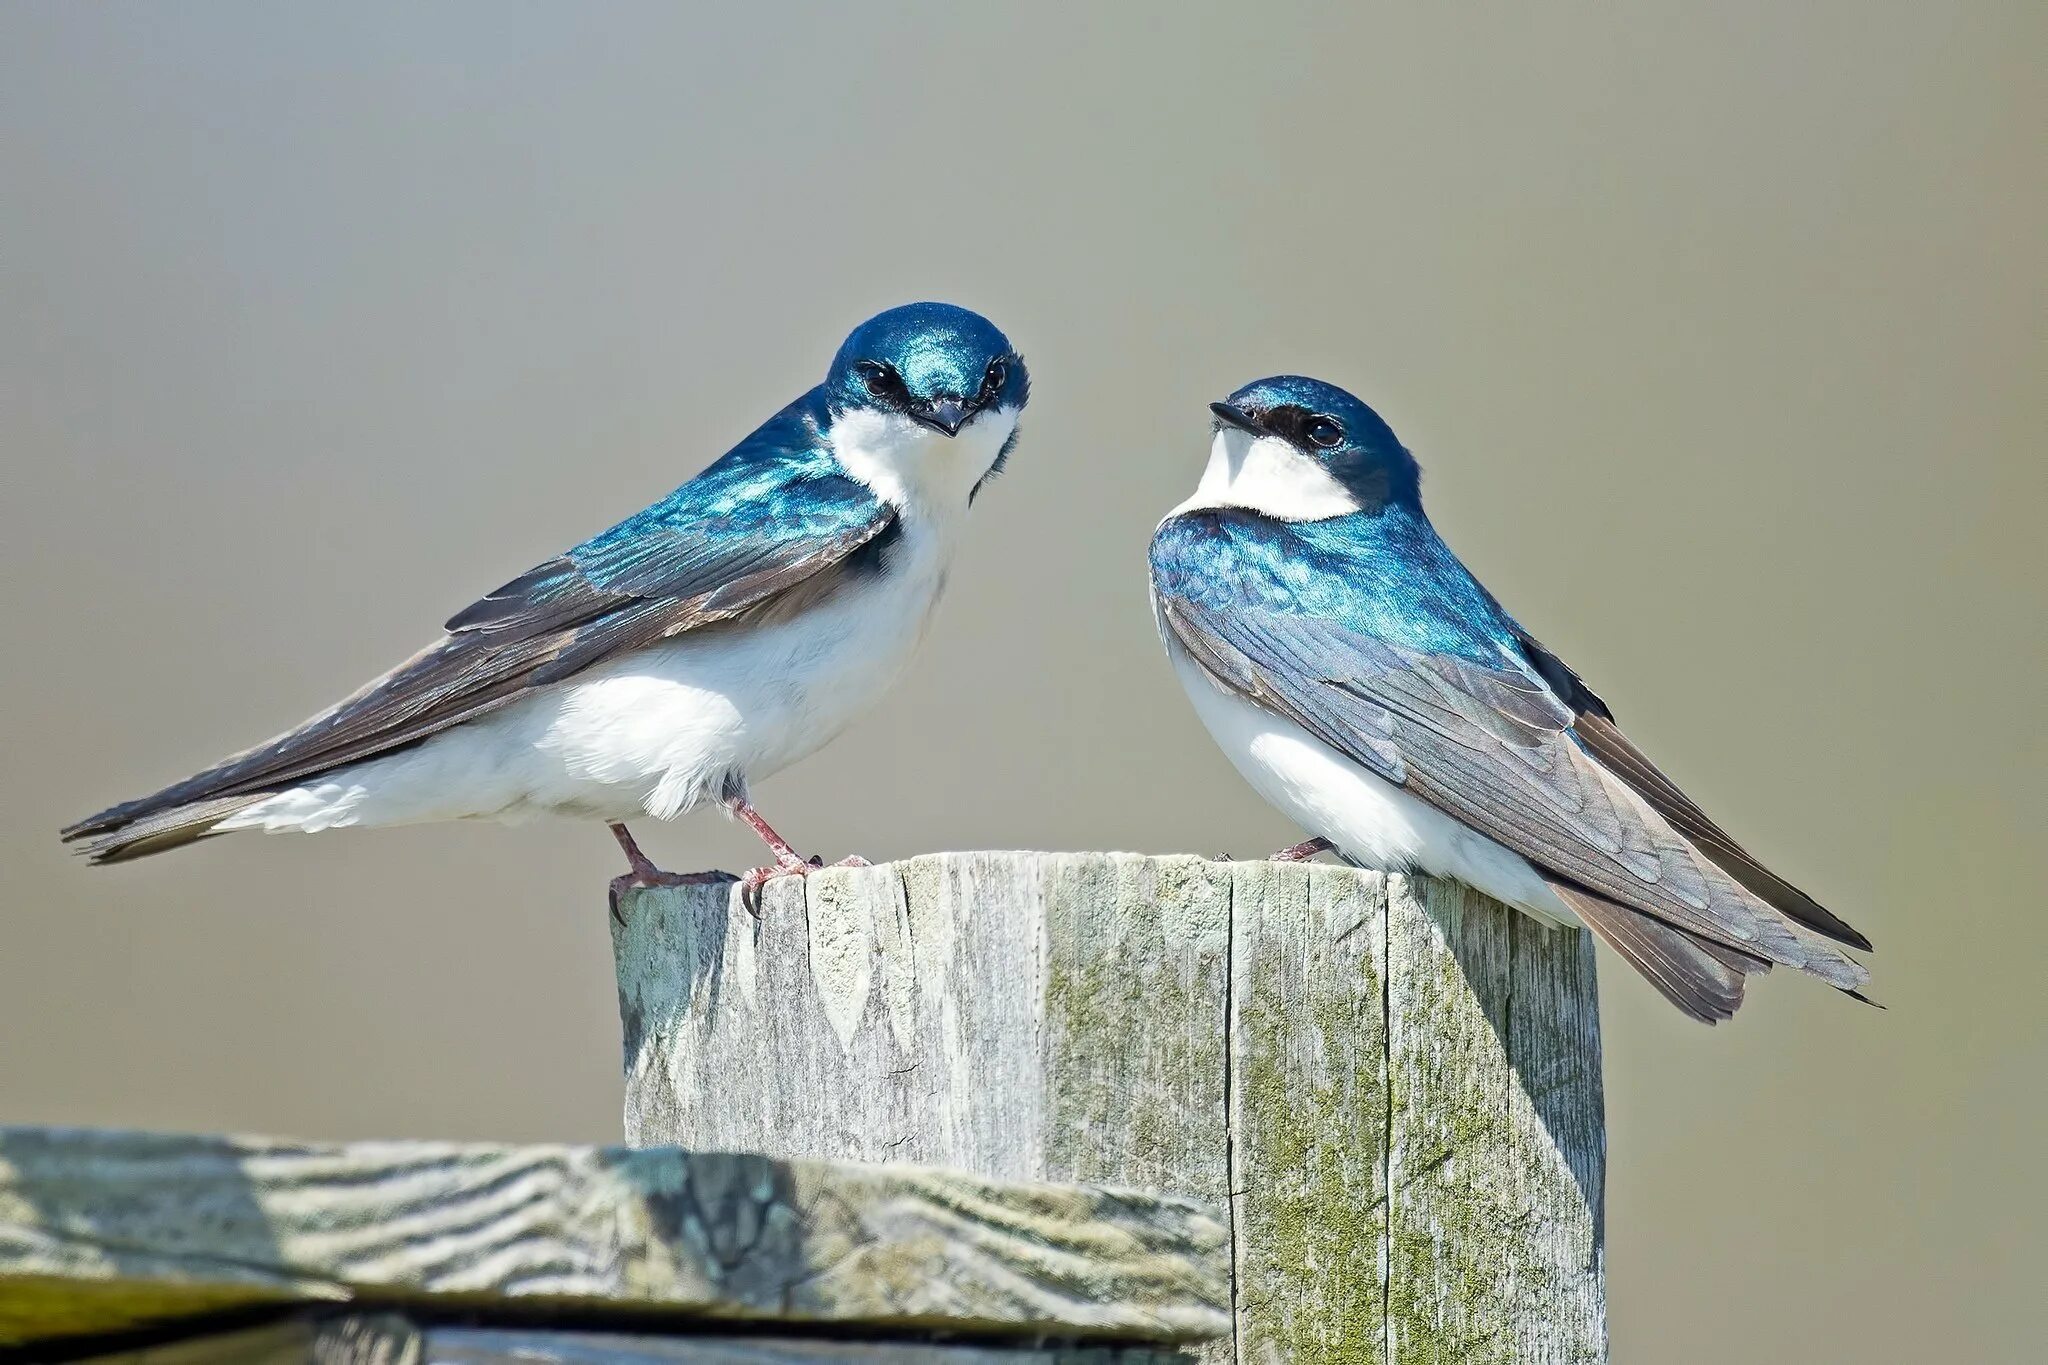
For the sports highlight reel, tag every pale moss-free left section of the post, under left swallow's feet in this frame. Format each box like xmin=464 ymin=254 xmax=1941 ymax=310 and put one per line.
xmin=614 ymin=853 xmax=1044 ymax=1179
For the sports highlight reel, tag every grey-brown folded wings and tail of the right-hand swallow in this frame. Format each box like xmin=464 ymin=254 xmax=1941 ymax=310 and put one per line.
xmin=1157 ymin=564 xmax=1868 ymax=1019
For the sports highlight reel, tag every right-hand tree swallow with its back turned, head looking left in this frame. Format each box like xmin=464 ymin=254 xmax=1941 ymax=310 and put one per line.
xmin=1151 ymin=375 xmax=1870 ymax=1023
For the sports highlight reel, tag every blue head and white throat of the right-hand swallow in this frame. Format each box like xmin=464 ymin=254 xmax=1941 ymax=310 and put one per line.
xmin=1204 ymin=375 xmax=1421 ymax=520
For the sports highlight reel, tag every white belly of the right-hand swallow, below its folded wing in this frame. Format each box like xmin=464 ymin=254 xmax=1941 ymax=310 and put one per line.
xmin=1165 ymin=634 xmax=1579 ymax=925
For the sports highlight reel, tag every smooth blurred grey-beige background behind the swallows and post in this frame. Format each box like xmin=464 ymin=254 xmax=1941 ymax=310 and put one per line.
xmin=0 ymin=0 xmax=2048 ymax=1363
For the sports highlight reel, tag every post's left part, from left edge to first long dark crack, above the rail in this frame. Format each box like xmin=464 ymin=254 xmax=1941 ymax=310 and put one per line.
xmin=612 ymin=853 xmax=1229 ymax=1203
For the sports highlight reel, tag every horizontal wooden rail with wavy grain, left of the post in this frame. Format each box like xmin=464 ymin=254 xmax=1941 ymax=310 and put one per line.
xmin=0 ymin=1126 xmax=1229 ymax=1347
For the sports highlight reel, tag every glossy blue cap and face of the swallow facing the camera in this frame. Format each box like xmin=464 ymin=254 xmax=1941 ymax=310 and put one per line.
xmin=825 ymin=303 xmax=1030 ymax=436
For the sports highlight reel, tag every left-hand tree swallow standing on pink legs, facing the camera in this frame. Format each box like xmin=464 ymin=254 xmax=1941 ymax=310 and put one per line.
xmin=63 ymin=303 xmax=1030 ymax=912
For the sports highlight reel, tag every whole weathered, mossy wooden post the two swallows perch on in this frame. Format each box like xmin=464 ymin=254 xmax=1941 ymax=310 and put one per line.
xmin=614 ymin=853 xmax=1606 ymax=1363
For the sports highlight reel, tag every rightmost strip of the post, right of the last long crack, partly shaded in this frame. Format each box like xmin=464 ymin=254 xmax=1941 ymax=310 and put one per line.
xmin=1384 ymin=878 xmax=1606 ymax=1365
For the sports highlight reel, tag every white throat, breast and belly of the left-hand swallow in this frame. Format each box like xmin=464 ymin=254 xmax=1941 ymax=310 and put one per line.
xmin=223 ymin=409 xmax=1016 ymax=831
